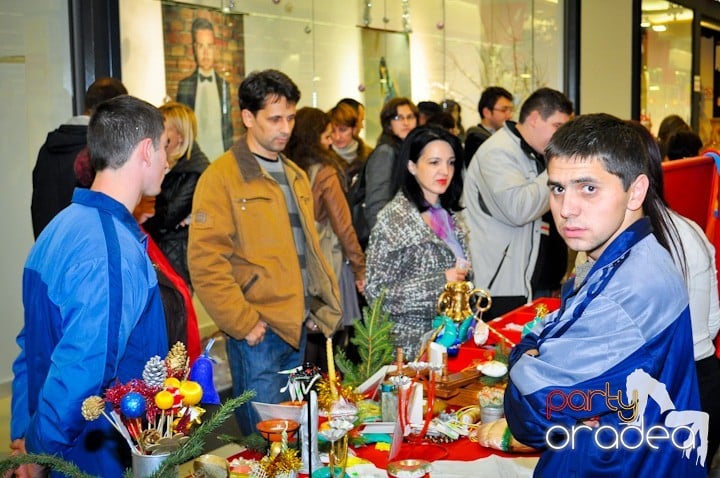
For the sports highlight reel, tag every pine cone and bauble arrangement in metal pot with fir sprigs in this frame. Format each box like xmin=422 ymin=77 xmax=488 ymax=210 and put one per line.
xmin=0 ymin=343 xmax=255 ymax=478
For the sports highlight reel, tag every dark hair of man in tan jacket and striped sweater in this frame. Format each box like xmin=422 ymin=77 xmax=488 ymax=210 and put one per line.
xmin=238 ymin=70 xmax=300 ymax=115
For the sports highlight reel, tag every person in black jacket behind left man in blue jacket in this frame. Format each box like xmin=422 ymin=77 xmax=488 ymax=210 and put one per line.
xmin=30 ymin=78 xmax=127 ymax=239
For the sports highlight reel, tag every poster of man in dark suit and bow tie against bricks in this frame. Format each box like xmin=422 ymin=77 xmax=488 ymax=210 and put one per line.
xmin=163 ymin=4 xmax=244 ymax=161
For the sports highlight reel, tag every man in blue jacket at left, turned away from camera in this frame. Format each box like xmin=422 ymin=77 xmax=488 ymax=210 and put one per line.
xmin=11 ymin=95 xmax=168 ymax=476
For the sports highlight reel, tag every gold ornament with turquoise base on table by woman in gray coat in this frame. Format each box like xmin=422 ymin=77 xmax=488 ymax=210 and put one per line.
xmin=430 ymin=281 xmax=492 ymax=359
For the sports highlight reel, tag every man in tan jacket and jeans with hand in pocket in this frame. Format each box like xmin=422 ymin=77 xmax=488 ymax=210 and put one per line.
xmin=188 ymin=70 xmax=341 ymax=435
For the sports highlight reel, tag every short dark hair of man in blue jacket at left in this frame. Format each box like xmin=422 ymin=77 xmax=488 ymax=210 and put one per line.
xmin=88 ymin=95 xmax=165 ymax=171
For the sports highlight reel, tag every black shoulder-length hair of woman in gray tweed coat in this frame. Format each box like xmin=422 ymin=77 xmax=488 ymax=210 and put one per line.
xmin=392 ymin=124 xmax=463 ymax=212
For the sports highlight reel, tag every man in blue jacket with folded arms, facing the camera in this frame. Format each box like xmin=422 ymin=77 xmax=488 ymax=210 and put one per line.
xmin=505 ymin=114 xmax=708 ymax=477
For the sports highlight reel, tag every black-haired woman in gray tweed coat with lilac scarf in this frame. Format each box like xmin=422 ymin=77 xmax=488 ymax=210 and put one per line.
xmin=365 ymin=126 xmax=470 ymax=360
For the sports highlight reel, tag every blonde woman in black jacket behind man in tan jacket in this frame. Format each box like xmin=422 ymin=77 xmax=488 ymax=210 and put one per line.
xmin=144 ymin=102 xmax=210 ymax=285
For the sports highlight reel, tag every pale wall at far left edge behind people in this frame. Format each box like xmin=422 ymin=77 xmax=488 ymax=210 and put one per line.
xmin=0 ymin=0 xmax=72 ymax=395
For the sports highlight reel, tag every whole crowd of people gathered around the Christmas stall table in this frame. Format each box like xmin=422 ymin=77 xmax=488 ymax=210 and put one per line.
xmin=12 ymin=61 xmax=720 ymax=476
